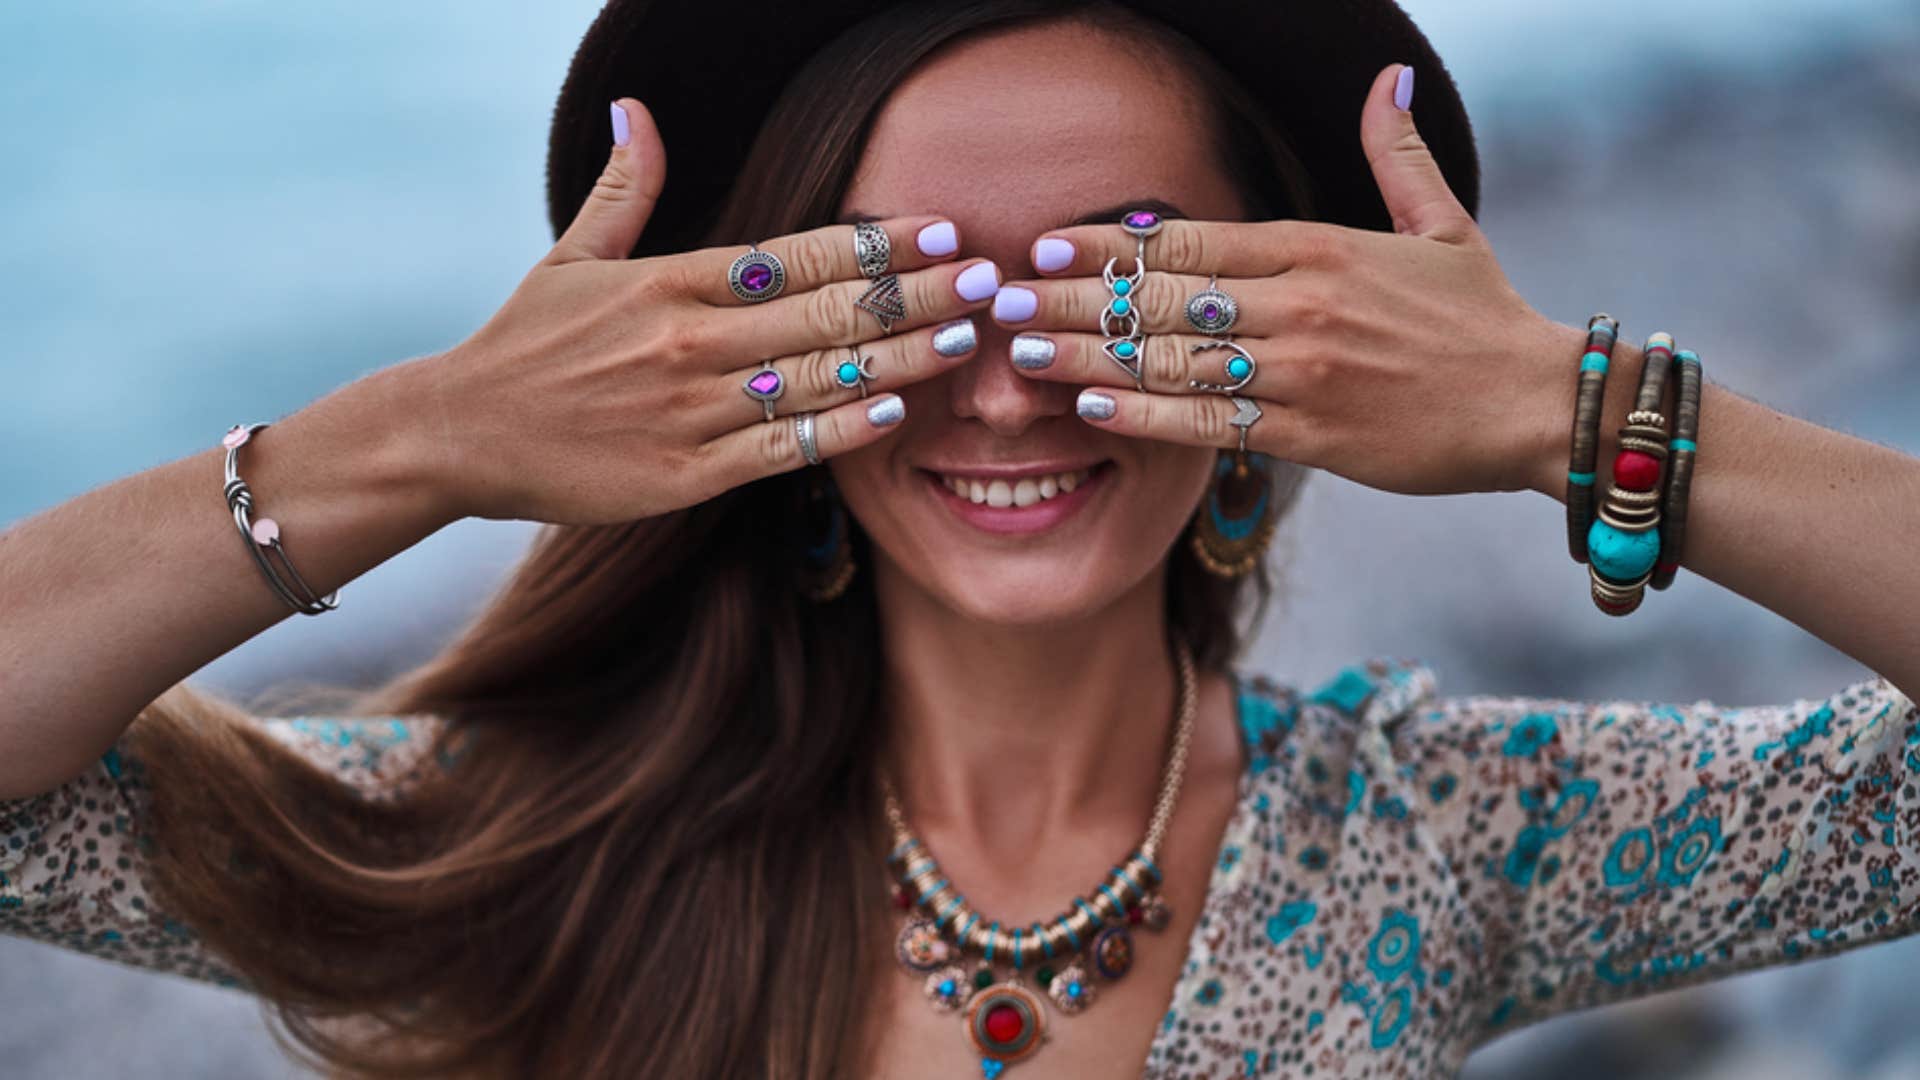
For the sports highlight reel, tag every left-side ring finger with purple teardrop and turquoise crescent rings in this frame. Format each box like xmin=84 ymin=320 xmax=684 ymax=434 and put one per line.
xmin=712 ymin=319 xmax=979 ymax=432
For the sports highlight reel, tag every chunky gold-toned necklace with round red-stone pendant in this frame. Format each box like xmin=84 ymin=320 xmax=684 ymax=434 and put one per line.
xmin=879 ymin=642 xmax=1196 ymax=1080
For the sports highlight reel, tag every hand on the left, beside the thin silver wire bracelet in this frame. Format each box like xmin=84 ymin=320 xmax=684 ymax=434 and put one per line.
xmin=409 ymin=100 xmax=998 ymax=525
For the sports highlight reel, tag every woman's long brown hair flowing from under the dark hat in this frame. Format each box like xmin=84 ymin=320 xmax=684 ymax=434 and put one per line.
xmin=129 ymin=0 xmax=1311 ymax=1080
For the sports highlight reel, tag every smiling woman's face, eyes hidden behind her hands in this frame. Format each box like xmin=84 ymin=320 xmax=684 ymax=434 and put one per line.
xmin=833 ymin=14 xmax=1242 ymax=623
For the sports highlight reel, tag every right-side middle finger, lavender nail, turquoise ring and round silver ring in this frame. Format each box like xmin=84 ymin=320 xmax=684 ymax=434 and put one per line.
xmin=993 ymin=269 xmax=1284 ymax=336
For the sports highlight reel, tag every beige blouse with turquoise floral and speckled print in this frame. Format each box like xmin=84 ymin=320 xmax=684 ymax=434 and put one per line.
xmin=0 ymin=659 xmax=1920 ymax=1080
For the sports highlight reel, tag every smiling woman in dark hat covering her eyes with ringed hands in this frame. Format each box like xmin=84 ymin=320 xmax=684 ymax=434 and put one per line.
xmin=0 ymin=0 xmax=1920 ymax=1078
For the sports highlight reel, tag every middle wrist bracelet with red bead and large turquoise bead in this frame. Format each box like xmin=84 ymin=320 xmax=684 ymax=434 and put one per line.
xmin=1586 ymin=332 xmax=1674 ymax=615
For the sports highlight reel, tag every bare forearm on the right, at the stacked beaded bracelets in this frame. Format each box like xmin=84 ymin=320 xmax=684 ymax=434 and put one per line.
xmin=1534 ymin=319 xmax=1920 ymax=700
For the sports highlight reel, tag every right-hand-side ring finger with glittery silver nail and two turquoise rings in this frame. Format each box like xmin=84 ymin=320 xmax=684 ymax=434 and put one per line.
xmin=1008 ymin=332 xmax=1296 ymax=402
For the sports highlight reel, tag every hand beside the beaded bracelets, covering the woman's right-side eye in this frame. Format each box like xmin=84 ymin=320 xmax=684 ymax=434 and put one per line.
xmin=995 ymin=65 xmax=1584 ymax=494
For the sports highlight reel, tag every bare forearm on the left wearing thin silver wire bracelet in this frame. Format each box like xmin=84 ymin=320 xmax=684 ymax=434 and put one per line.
xmin=0 ymin=357 xmax=453 ymax=798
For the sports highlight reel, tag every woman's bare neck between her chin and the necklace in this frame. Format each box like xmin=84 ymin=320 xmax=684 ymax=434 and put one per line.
xmin=876 ymin=557 xmax=1177 ymax=878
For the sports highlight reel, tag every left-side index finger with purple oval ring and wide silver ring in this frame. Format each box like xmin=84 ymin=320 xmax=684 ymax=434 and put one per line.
xmin=676 ymin=213 xmax=960 ymax=307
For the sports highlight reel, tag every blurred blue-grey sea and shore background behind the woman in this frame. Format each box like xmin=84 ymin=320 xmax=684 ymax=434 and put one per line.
xmin=0 ymin=0 xmax=1920 ymax=1080
